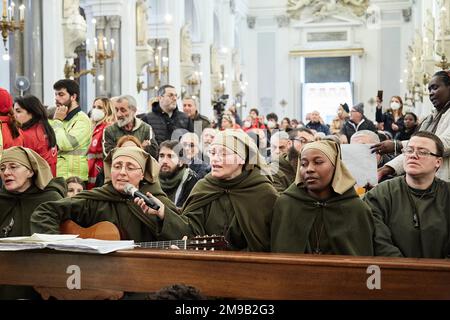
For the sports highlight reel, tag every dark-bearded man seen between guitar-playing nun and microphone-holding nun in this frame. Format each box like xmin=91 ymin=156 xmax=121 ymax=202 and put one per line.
xmin=158 ymin=140 xmax=198 ymax=208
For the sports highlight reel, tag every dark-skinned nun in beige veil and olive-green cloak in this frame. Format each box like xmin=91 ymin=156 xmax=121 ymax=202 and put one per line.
xmin=271 ymin=141 xmax=374 ymax=256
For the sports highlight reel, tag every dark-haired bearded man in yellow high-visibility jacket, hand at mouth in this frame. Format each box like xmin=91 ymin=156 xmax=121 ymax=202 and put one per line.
xmin=51 ymin=79 xmax=92 ymax=181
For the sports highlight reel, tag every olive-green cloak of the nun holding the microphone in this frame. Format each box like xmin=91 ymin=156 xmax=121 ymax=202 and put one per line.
xmin=160 ymin=169 xmax=278 ymax=251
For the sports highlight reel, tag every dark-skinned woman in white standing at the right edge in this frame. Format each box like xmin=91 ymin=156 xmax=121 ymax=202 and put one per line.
xmin=372 ymin=70 xmax=450 ymax=182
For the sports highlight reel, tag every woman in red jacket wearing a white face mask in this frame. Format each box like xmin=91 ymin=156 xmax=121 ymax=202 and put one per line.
xmin=87 ymin=98 xmax=115 ymax=190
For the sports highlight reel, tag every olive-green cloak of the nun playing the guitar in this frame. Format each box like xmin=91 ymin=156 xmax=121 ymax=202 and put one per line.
xmin=31 ymin=183 xmax=176 ymax=242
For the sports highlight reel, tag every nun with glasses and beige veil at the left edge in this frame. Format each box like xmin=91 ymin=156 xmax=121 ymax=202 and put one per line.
xmin=0 ymin=147 xmax=66 ymax=300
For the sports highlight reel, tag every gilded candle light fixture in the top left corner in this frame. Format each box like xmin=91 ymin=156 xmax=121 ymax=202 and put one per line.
xmin=0 ymin=0 xmax=25 ymax=60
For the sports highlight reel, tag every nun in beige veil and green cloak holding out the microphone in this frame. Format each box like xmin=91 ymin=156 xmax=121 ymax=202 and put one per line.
xmin=135 ymin=130 xmax=278 ymax=251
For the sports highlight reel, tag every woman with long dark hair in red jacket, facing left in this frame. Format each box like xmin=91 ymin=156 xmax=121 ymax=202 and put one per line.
xmin=14 ymin=95 xmax=58 ymax=177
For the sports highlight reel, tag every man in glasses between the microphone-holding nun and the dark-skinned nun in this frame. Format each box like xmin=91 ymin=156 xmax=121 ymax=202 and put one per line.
xmin=270 ymin=128 xmax=314 ymax=192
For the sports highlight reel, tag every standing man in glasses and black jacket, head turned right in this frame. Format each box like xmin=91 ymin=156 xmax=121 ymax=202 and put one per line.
xmin=142 ymin=85 xmax=194 ymax=144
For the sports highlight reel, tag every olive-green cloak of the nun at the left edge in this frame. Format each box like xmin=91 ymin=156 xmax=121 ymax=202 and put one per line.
xmin=0 ymin=178 xmax=66 ymax=238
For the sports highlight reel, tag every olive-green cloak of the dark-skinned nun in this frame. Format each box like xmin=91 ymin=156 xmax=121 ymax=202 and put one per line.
xmin=271 ymin=184 xmax=374 ymax=256
